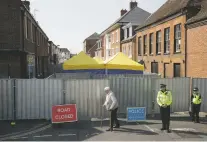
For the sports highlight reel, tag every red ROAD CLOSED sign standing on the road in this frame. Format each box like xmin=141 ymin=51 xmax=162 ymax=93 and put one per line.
xmin=52 ymin=104 xmax=78 ymax=123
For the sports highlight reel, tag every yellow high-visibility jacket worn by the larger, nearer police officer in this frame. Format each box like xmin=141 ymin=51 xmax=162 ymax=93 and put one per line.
xmin=157 ymin=91 xmax=172 ymax=106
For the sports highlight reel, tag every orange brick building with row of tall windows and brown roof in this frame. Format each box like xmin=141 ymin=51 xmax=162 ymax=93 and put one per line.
xmin=135 ymin=0 xmax=201 ymax=78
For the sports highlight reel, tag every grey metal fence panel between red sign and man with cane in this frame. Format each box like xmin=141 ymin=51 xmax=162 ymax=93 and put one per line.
xmin=65 ymin=79 xmax=109 ymax=120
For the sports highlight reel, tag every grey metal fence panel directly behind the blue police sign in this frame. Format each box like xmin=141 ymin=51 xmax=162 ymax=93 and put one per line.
xmin=110 ymin=77 xmax=153 ymax=114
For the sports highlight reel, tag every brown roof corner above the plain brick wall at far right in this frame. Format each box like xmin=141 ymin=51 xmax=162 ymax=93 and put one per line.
xmin=186 ymin=0 xmax=207 ymax=24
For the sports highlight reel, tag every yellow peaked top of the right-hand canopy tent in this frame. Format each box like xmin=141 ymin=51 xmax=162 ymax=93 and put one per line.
xmin=105 ymin=52 xmax=144 ymax=71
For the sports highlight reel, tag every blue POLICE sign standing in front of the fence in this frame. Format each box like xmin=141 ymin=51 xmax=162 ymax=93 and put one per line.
xmin=127 ymin=107 xmax=146 ymax=122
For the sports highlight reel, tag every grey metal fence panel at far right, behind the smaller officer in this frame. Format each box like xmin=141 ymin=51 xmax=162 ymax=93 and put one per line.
xmin=192 ymin=78 xmax=207 ymax=112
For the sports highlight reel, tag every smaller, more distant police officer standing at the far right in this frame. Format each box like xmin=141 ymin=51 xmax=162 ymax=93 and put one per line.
xmin=191 ymin=87 xmax=201 ymax=123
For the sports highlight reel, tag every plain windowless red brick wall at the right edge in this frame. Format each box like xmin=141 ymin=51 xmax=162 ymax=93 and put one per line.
xmin=187 ymin=25 xmax=207 ymax=78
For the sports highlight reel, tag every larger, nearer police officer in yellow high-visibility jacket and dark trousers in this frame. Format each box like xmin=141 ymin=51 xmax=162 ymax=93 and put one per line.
xmin=157 ymin=84 xmax=172 ymax=133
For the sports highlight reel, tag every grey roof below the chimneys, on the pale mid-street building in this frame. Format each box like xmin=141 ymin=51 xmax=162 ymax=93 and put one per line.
xmin=101 ymin=7 xmax=150 ymax=35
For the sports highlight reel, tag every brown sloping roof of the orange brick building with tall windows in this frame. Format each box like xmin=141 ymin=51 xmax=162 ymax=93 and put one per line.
xmin=136 ymin=0 xmax=191 ymax=30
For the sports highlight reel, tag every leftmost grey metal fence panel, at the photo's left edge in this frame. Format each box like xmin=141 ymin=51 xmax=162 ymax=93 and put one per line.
xmin=0 ymin=79 xmax=14 ymax=120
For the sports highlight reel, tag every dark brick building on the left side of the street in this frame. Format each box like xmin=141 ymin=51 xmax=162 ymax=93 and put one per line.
xmin=0 ymin=0 xmax=49 ymax=78
